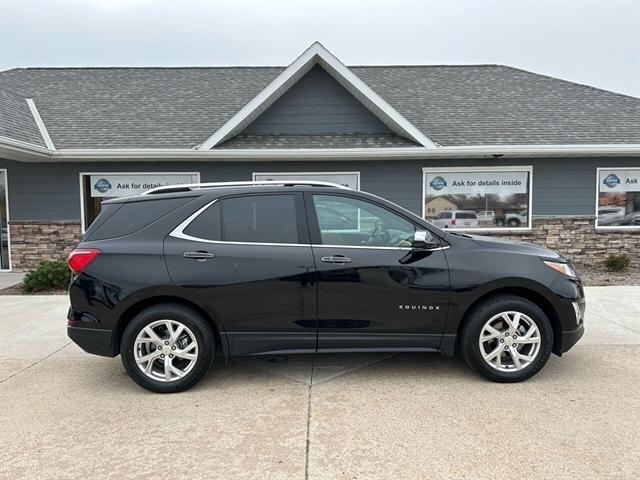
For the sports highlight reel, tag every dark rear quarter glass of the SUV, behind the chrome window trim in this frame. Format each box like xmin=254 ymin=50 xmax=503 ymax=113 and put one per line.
xmin=85 ymin=197 xmax=193 ymax=240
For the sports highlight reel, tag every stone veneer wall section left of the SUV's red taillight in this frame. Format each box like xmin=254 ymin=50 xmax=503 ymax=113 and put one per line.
xmin=10 ymin=221 xmax=82 ymax=272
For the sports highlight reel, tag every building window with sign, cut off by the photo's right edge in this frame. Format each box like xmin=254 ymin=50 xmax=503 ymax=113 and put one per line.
xmin=596 ymin=167 xmax=640 ymax=229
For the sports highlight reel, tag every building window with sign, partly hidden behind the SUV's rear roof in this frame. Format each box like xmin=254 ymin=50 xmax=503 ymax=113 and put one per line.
xmin=80 ymin=172 xmax=200 ymax=232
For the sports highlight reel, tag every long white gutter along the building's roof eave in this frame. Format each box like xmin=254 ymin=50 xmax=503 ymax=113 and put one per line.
xmin=0 ymin=137 xmax=640 ymax=162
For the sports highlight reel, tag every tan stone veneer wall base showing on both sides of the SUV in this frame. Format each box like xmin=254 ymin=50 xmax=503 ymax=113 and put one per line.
xmin=6 ymin=217 xmax=640 ymax=271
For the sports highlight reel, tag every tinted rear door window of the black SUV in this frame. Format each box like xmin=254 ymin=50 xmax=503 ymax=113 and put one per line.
xmin=222 ymin=195 xmax=298 ymax=243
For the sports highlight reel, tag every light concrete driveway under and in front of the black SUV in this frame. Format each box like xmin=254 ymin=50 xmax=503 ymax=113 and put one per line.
xmin=0 ymin=287 xmax=640 ymax=479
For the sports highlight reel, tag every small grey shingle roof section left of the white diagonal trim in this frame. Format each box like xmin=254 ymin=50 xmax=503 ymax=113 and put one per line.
xmin=0 ymin=88 xmax=45 ymax=147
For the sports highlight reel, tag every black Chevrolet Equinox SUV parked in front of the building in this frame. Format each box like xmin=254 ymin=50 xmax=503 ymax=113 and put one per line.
xmin=68 ymin=181 xmax=585 ymax=392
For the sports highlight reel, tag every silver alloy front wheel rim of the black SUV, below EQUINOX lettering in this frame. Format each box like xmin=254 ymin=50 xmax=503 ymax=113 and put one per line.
xmin=478 ymin=311 xmax=541 ymax=372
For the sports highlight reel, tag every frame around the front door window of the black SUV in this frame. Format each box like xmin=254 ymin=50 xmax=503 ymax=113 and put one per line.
xmin=304 ymin=191 xmax=436 ymax=251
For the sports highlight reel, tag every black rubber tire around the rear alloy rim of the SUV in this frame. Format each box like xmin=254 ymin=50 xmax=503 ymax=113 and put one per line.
xmin=120 ymin=304 xmax=215 ymax=393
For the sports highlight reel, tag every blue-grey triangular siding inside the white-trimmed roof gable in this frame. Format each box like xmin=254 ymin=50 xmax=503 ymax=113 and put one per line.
xmin=243 ymin=65 xmax=391 ymax=135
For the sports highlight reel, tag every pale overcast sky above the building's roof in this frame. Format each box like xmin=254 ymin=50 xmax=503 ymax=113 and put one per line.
xmin=0 ymin=0 xmax=640 ymax=96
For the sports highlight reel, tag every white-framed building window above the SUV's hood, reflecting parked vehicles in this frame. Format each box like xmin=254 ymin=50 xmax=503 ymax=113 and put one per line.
xmin=422 ymin=166 xmax=533 ymax=230
